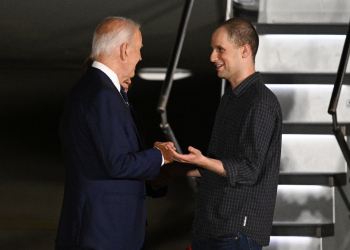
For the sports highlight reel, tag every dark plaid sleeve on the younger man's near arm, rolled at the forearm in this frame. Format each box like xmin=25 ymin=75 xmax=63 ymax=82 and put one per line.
xmin=221 ymin=101 xmax=275 ymax=186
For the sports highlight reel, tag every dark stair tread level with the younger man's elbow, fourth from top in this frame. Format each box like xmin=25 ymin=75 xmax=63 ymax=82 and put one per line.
xmin=279 ymin=173 xmax=347 ymax=187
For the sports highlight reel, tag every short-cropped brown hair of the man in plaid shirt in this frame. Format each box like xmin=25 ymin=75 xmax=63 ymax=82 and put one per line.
xmin=219 ymin=18 xmax=259 ymax=61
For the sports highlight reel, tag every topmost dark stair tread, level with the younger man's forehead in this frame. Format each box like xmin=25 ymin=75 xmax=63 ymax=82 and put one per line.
xmin=256 ymin=23 xmax=349 ymax=35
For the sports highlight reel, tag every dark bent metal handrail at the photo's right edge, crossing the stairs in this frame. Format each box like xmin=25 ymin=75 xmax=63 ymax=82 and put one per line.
xmin=328 ymin=23 xmax=350 ymax=168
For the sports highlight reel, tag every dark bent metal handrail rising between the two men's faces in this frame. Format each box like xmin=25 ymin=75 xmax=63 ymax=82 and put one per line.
xmin=157 ymin=0 xmax=194 ymax=154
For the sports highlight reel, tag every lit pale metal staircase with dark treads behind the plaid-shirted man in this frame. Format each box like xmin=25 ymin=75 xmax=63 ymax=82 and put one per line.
xmin=252 ymin=0 xmax=350 ymax=250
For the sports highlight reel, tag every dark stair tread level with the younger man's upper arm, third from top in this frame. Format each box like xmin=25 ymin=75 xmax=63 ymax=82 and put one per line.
xmin=283 ymin=123 xmax=350 ymax=136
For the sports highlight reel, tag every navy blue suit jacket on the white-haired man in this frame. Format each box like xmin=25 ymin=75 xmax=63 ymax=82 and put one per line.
xmin=56 ymin=67 xmax=162 ymax=250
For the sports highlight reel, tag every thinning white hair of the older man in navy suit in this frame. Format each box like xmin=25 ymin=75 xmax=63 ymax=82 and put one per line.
xmin=90 ymin=17 xmax=140 ymax=59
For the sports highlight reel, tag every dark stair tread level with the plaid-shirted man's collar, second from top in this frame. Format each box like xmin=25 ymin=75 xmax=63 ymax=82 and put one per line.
xmin=260 ymin=72 xmax=350 ymax=85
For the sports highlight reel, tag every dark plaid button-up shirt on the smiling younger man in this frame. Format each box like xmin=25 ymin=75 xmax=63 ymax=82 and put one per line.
xmin=192 ymin=72 xmax=282 ymax=246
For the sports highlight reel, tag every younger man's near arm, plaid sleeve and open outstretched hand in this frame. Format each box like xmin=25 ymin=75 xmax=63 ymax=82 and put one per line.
xmin=170 ymin=102 xmax=275 ymax=186
